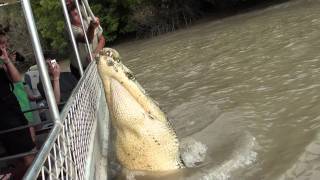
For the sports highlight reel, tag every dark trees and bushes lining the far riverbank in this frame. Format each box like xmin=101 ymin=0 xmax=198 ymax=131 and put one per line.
xmin=32 ymin=0 xmax=286 ymax=49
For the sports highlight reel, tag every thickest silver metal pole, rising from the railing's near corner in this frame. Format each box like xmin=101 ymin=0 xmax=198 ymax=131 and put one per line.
xmin=21 ymin=0 xmax=61 ymax=123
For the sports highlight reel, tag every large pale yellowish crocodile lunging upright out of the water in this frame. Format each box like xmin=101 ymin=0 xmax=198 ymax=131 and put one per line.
xmin=96 ymin=48 xmax=184 ymax=171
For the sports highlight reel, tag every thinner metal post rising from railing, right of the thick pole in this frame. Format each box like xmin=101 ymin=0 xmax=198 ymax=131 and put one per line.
xmin=60 ymin=0 xmax=83 ymax=77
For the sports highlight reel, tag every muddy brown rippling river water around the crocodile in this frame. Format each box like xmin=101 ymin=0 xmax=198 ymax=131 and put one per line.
xmin=115 ymin=0 xmax=320 ymax=180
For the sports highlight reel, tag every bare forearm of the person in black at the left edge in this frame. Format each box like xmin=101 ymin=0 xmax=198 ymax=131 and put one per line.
xmin=1 ymin=47 xmax=22 ymax=83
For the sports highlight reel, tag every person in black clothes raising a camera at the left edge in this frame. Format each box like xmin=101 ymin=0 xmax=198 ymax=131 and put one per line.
xmin=0 ymin=33 xmax=35 ymax=179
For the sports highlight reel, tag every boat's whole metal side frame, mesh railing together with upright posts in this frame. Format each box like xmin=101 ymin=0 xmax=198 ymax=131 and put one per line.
xmin=16 ymin=0 xmax=109 ymax=180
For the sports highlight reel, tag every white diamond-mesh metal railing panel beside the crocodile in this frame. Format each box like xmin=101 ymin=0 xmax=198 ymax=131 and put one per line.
xmin=24 ymin=63 xmax=108 ymax=180
